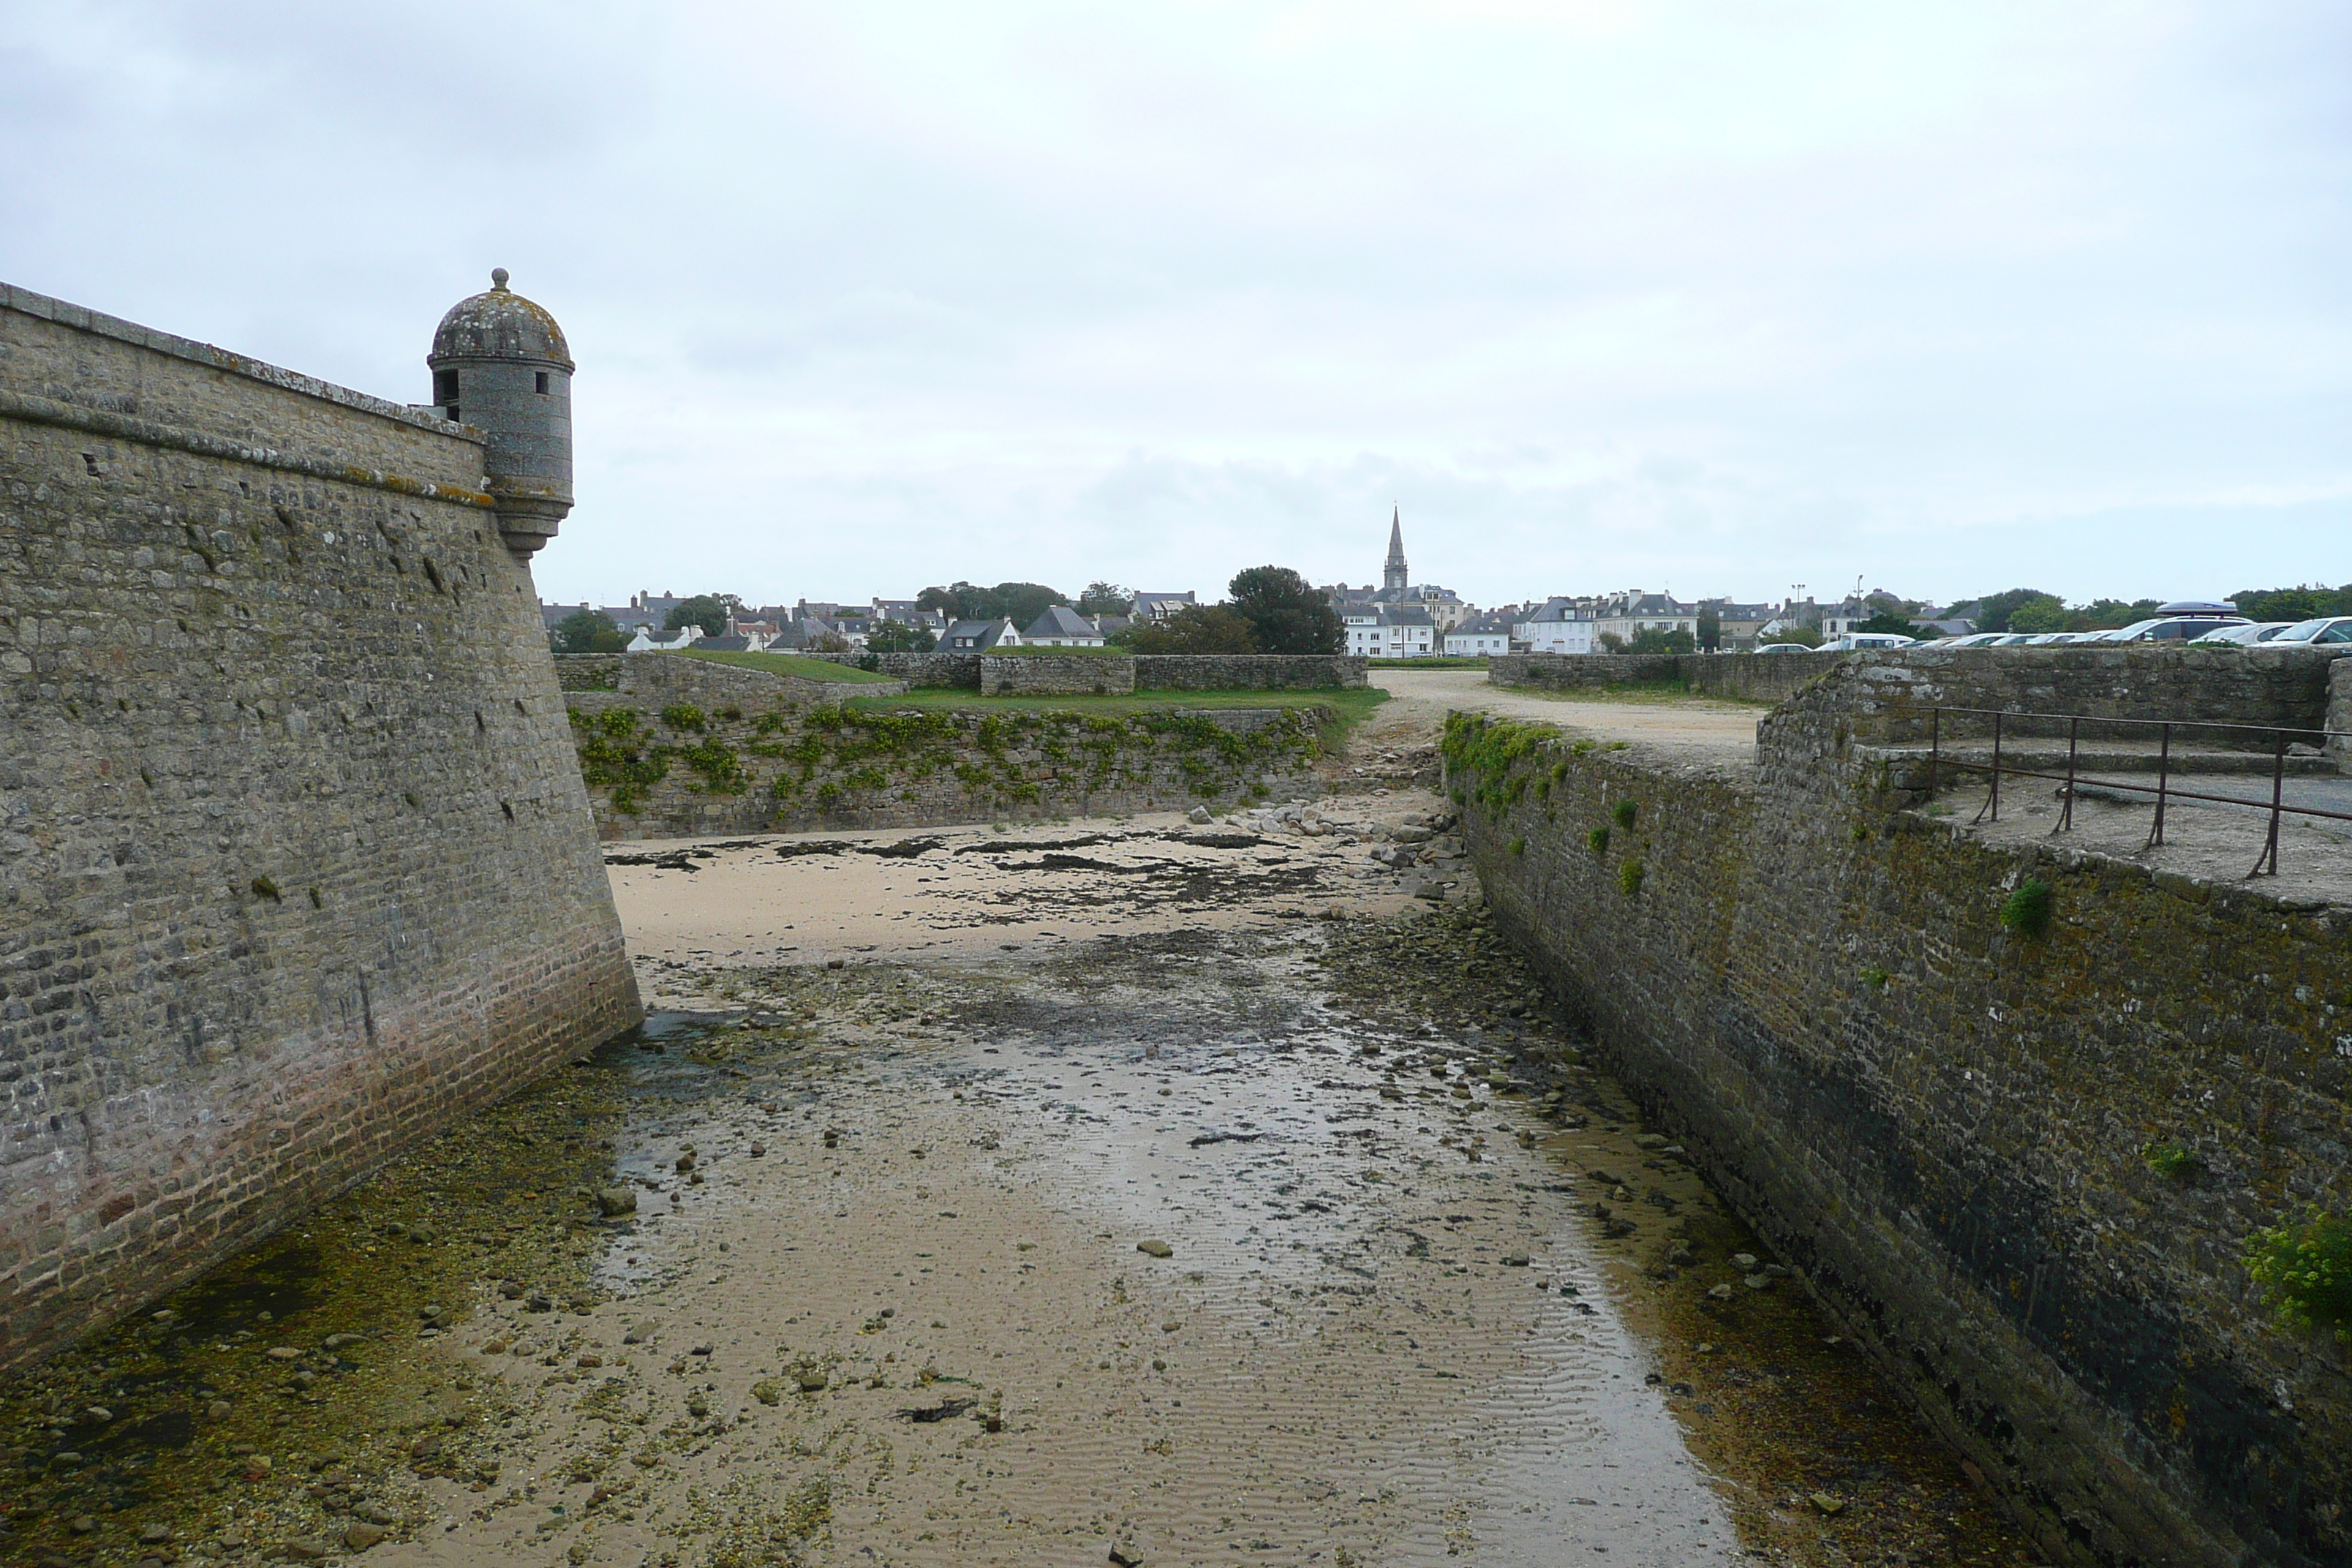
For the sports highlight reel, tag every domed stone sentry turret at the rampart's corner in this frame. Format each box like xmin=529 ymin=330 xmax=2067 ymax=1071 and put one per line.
xmin=426 ymin=265 xmax=571 ymax=562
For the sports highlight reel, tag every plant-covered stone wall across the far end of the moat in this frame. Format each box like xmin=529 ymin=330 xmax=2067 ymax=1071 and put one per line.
xmin=569 ymin=691 xmax=1329 ymax=840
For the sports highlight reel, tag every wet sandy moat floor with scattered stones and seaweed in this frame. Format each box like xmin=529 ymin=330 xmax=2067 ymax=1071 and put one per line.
xmin=0 ymin=792 xmax=2035 ymax=1568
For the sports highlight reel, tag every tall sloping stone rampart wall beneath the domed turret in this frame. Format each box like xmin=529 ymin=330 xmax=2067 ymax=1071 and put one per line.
xmin=0 ymin=289 xmax=638 ymax=1363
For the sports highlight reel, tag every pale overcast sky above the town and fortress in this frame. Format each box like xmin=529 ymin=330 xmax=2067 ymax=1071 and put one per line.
xmin=0 ymin=0 xmax=2352 ymax=604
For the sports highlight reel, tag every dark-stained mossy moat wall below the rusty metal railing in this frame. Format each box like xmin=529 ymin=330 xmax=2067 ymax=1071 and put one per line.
xmin=1447 ymin=715 xmax=2352 ymax=1568
